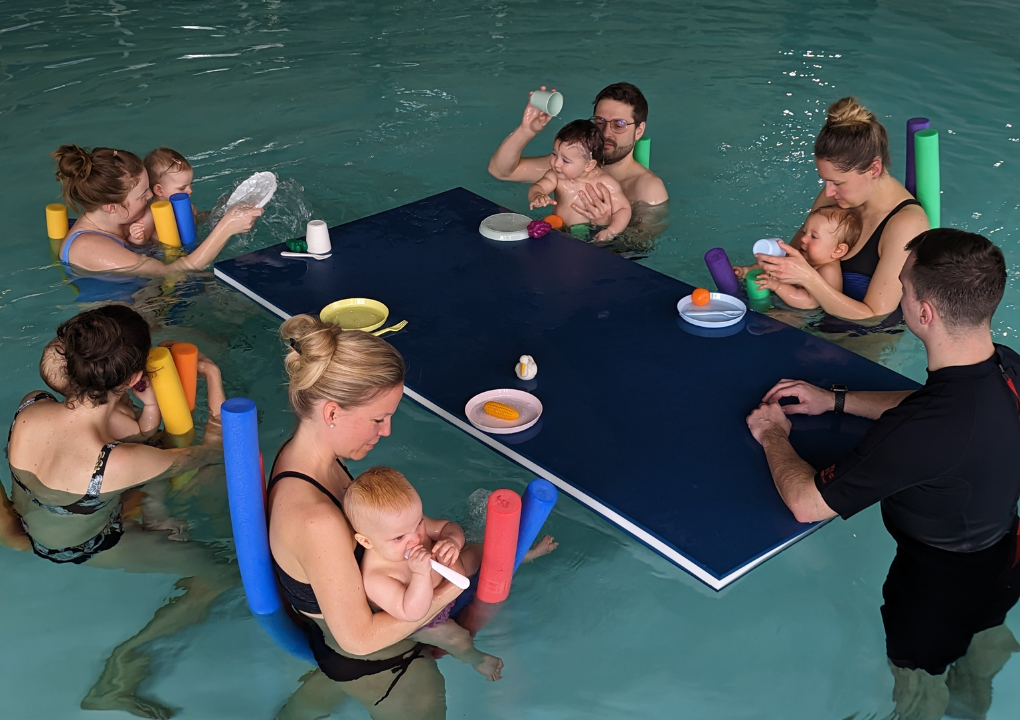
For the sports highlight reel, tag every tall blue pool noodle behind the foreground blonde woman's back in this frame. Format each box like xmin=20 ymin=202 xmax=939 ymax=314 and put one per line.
xmin=220 ymin=398 xmax=315 ymax=663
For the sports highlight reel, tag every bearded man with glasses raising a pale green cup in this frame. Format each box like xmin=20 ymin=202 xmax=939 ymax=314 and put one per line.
xmin=489 ymin=83 xmax=669 ymax=225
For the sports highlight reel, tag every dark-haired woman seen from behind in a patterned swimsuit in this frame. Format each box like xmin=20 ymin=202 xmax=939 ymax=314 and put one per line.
xmin=7 ymin=305 xmax=237 ymax=718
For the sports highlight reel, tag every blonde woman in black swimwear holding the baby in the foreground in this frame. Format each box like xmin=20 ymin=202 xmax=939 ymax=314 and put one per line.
xmin=269 ymin=315 xmax=460 ymax=720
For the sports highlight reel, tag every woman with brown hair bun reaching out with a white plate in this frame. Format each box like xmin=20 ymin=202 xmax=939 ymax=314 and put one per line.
xmin=53 ymin=145 xmax=262 ymax=279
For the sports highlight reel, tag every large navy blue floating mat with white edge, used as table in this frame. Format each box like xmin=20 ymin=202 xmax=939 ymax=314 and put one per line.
xmin=215 ymin=188 xmax=916 ymax=589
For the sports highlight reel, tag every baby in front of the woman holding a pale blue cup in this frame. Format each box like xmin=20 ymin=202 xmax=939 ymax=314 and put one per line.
xmin=733 ymin=205 xmax=861 ymax=310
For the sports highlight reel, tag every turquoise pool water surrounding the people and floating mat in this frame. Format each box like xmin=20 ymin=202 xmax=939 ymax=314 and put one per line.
xmin=0 ymin=0 xmax=1020 ymax=719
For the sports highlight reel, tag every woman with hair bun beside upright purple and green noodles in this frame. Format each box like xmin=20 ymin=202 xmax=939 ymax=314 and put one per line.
xmin=757 ymin=98 xmax=928 ymax=320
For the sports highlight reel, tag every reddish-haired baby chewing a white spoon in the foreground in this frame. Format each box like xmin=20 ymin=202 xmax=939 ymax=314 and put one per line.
xmin=344 ymin=467 xmax=503 ymax=680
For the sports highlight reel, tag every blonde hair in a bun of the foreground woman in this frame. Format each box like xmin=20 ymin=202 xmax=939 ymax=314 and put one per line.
xmin=279 ymin=315 xmax=404 ymax=417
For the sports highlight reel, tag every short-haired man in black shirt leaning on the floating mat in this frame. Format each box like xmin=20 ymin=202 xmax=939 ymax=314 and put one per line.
xmin=748 ymin=228 xmax=1020 ymax=718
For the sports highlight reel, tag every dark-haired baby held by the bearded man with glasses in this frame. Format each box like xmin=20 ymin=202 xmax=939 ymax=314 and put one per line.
xmin=527 ymin=120 xmax=630 ymax=243
